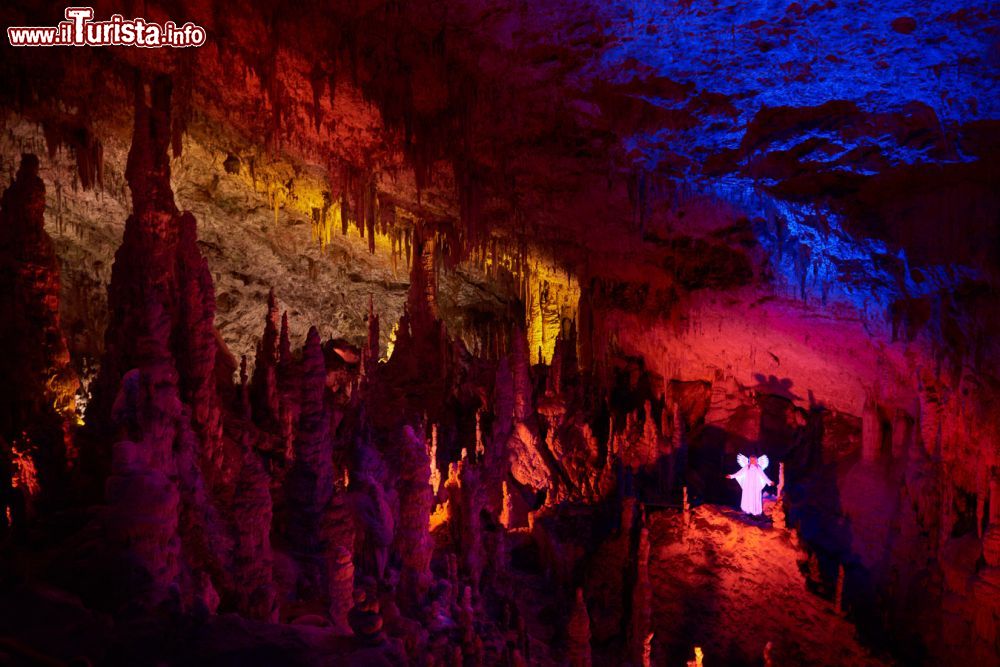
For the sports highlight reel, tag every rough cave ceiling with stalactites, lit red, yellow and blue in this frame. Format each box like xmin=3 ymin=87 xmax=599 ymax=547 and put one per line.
xmin=3 ymin=1 xmax=1000 ymax=408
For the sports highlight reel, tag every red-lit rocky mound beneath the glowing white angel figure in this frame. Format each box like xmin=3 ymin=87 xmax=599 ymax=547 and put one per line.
xmin=648 ymin=503 xmax=889 ymax=665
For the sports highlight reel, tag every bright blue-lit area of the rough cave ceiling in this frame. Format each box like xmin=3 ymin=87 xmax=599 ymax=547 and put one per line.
xmin=591 ymin=0 xmax=1000 ymax=318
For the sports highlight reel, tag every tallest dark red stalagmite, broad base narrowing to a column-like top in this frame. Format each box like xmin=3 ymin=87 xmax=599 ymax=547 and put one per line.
xmin=88 ymin=77 xmax=254 ymax=616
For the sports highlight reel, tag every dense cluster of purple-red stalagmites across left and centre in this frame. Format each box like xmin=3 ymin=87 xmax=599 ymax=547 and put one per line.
xmin=2 ymin=74 xmax=656 ymax=665
